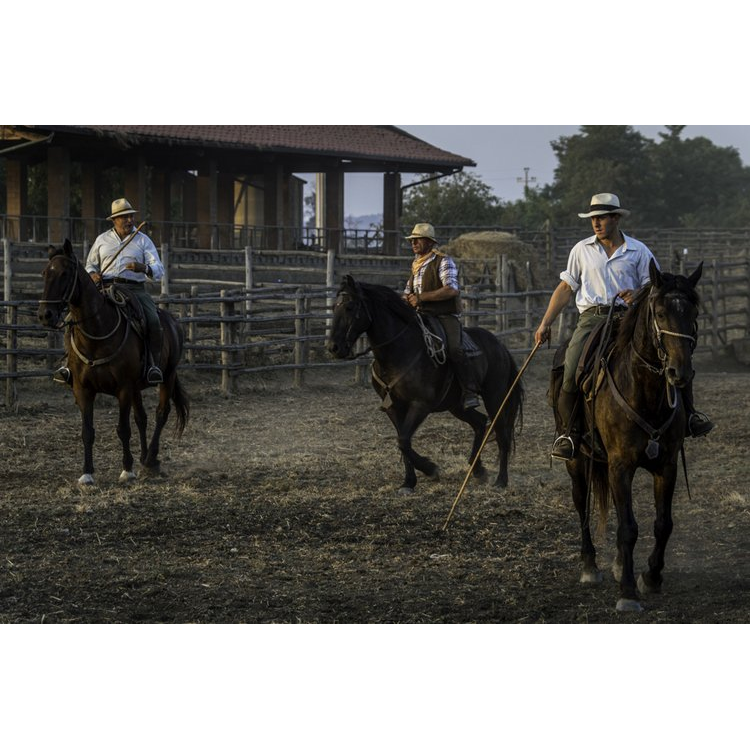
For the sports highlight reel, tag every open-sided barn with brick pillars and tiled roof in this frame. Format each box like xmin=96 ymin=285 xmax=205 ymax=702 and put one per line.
xmin=0 ymin=125 xmax=476 ymax=253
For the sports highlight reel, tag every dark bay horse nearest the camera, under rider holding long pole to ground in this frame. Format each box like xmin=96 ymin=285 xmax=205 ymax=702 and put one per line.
xmin=551 ymin=261 xmax=703 ymax=612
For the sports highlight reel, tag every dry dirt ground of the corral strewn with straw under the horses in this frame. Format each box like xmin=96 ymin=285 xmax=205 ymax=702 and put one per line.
xmin=0 ymin=351 xmax=750 ymax=623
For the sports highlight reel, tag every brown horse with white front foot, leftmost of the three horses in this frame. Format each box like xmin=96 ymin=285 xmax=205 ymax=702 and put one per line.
xmin=38 ymin=239 xmax=190 ymax=487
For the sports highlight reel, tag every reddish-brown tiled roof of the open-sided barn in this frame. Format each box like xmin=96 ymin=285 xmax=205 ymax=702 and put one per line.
xmin=53 ymin=125 xmax=475 ymax=168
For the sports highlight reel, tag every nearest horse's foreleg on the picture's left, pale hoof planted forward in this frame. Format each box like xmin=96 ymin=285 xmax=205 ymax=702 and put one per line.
xmin=609 ymin=458 xmax=643 ymax=612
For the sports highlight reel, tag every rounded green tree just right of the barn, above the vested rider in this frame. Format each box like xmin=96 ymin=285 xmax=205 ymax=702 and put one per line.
xmin=402 ymin=172 xmax=501 ymax=227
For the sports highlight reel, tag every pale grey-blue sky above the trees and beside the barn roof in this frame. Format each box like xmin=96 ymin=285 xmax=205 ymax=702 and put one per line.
xmin=338 ymin=125 xmax=750 ymax=216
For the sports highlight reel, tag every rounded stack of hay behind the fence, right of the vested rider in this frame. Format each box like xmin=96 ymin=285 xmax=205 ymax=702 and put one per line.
xmin=440 ymin=231 xmax=544 ymax=291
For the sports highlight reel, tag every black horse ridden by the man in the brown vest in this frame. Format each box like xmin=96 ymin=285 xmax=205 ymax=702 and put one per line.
xmin=328 ymin=276 xmax=523 ymax=494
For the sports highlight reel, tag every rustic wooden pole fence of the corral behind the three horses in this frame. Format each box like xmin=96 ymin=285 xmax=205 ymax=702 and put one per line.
xmin=0 ymin=254 xmax=750 ymax=406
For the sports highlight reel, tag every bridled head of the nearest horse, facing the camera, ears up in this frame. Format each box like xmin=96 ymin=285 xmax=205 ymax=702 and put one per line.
xmin=648 ymin=260 xmax=703 ymax=388
